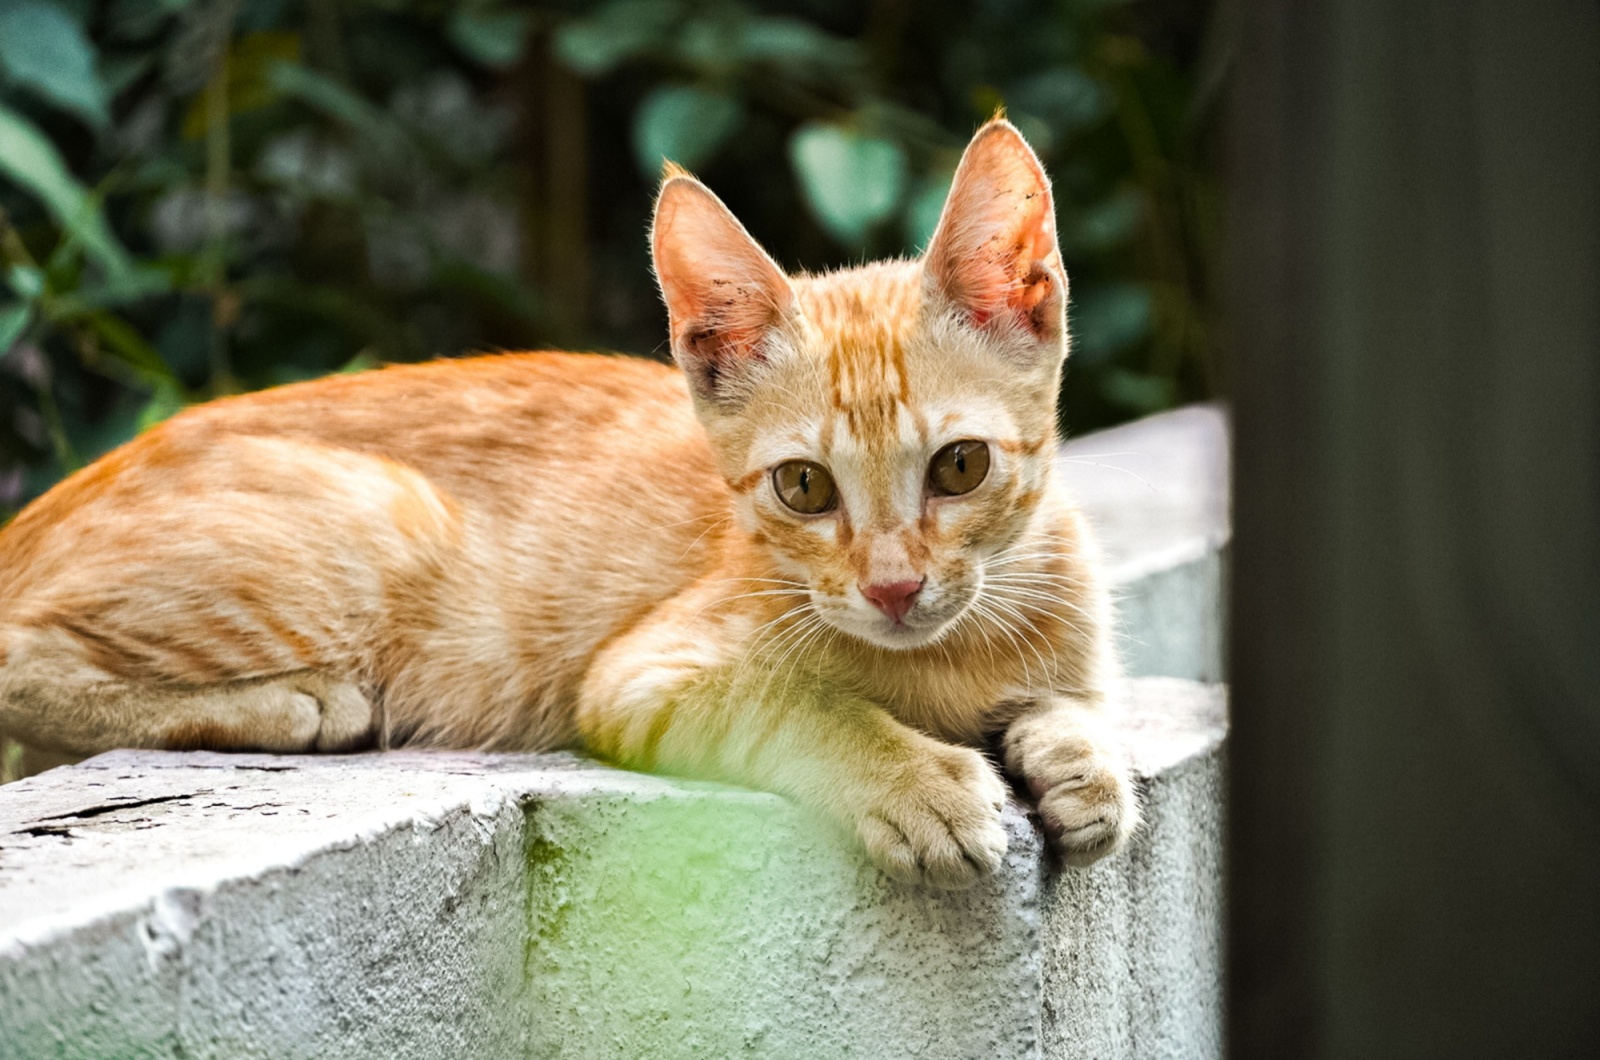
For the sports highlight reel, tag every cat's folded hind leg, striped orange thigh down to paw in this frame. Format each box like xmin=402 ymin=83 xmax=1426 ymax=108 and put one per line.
xmin=0 ymin=437 xmax=462 ymax=754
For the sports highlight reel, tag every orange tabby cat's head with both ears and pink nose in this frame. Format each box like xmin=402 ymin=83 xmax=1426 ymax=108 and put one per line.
xmin=651 ymin=120 xmax=1067 ymax=648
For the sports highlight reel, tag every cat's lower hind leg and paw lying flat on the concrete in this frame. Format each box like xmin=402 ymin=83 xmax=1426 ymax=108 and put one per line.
xmin=0 ymin=634 xmax=374 ymax=754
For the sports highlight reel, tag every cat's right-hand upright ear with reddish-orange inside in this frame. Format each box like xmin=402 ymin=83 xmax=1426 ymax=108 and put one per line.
xmin=923 ymin=118 xmax=1067 ymax=352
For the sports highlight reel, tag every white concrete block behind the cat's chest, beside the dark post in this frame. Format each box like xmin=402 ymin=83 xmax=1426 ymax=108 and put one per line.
xmin=1059 ymin=405 xmax=1232 ymax=682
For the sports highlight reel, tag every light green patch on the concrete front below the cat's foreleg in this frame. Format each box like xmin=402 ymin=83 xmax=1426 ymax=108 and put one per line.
xmin=522 ymin=794 xmax=859 ymax=1060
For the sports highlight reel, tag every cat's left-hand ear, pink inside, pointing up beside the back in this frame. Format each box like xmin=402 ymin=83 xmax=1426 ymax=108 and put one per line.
xmin=650 ymin=174 xmax=794 ymax=404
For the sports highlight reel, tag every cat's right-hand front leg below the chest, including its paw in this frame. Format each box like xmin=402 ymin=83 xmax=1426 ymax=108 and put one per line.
xmin=1002 ymin=697 xmax=1139 ymax=866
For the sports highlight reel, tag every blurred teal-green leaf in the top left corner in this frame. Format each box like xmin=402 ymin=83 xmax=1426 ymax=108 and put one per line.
xmin=0 ymin=0 xmax=109 ymax=128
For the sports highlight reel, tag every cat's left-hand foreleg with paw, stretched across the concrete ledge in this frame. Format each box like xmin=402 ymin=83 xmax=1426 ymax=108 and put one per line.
xmin=578 ymin=607 xmax=1006 ymax=889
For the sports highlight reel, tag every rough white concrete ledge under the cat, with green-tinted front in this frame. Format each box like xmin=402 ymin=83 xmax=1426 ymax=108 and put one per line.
xmin=0 ymin=681 xmax=1222 ymax=1058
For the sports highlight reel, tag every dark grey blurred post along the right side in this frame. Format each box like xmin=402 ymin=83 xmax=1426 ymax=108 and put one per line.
xmin=1230 ymin=0 xmax=1600 ymax=1060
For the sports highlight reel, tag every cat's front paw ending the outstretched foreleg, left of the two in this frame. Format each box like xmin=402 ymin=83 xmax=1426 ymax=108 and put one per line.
xmin=856 ymin=740 xmax=1006 ymax=890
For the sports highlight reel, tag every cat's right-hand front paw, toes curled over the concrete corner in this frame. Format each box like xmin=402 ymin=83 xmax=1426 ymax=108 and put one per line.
xmin=1008 ymin=737 xmax=1139 ymax=866
